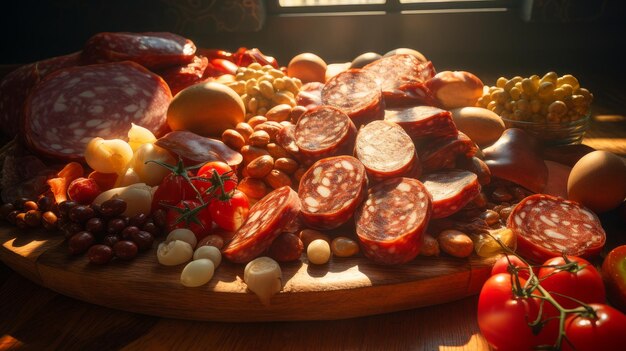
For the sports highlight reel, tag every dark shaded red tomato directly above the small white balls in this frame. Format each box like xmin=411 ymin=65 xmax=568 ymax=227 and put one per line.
xmin=166 ymin=200 xmax=213 ymax=240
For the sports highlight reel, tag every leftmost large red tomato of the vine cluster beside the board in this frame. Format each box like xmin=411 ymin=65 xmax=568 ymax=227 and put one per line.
xmin=478 ymin=273 xmax=556 ymax=350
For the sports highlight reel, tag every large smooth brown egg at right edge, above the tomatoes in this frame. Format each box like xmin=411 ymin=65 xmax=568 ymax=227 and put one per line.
xmin=567 ymin=151 xmax=626 ymax=213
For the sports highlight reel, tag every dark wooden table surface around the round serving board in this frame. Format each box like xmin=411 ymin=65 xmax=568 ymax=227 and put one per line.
xmin=0 ymin=66 xmax=626 ymax=350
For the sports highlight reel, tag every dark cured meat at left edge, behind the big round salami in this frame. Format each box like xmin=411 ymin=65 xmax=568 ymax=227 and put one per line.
xmin=0 ymin=53 xmax=80 ymax=139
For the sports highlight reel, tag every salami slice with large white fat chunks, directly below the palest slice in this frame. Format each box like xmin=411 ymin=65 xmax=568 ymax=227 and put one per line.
xmin=298 ymin=156 xmax=367 ymax=229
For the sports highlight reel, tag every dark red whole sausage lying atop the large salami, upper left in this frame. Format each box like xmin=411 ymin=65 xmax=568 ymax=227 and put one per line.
xmin=83 ymin=32 xmax=196 ymax=70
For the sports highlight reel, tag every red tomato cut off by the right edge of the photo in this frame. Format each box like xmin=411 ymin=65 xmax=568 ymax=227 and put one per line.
xmin=602 ymin=245 xmax=626 ymax=312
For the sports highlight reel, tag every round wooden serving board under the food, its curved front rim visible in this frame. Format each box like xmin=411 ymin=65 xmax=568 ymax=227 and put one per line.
xmin=0 ymin=225 xmax=493 ymax=322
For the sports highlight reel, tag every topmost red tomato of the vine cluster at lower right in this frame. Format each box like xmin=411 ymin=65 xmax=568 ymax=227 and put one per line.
xmin=538 ymin=256 xmax=606 ymax=308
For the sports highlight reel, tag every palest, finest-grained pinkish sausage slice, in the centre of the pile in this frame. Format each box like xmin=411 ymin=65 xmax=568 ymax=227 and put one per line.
xmin=354 ymin=121 xmax=421 ymax=180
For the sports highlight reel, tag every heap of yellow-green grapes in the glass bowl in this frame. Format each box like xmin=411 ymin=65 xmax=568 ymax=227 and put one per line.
xmin=477 ymin=72 xmax=593 ymax=123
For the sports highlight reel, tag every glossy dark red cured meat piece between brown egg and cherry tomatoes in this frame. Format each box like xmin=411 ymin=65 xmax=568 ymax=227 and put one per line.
xmin=155 ymin=130 xmax=243 ymax=167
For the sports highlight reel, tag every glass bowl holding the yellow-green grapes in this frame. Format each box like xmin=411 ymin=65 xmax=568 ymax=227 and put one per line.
xmin=502 ymin=113 xmax=591 ymax=146
